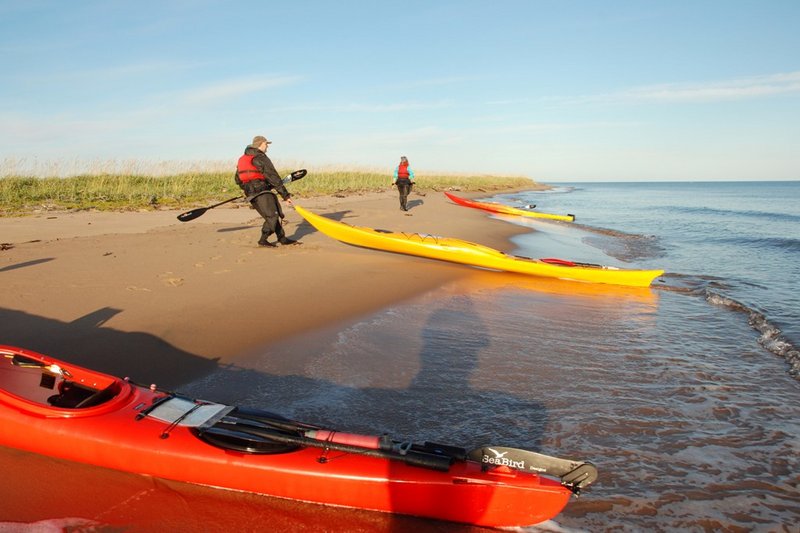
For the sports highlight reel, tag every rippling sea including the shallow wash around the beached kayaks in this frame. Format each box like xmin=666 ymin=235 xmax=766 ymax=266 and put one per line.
xmin=4 ymin=182 xmax=800 ymax=532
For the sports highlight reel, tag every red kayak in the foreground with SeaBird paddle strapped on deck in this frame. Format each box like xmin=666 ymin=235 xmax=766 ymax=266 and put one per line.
xmin=0 ymin=345 xmax=597 ymax=527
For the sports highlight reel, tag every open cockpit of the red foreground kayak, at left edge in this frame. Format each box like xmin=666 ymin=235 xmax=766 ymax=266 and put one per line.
xmin=0 ymin=351 xmax=127 ymax=414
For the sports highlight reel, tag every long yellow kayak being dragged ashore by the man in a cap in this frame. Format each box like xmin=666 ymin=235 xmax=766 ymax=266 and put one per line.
xmin=294 ymin=205 xmax=664 ymax=287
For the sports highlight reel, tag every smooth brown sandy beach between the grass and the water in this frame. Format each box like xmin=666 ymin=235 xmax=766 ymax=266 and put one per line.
xmin=0 ymin=190 xmax=536 ymax=387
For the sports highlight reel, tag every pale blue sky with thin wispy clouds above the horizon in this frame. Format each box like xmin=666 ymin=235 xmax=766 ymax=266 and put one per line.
xmin=0 ymin=0 xmax=800 ymax=182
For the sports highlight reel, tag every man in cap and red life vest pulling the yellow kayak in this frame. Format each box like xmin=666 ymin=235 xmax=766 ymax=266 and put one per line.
xmin=235 ymin=135 xmax=297 ymax=248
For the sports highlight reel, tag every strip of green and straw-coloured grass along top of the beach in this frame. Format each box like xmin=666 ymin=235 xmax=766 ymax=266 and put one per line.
xmin=0 ymin=170 xmax=534 ymax=216
